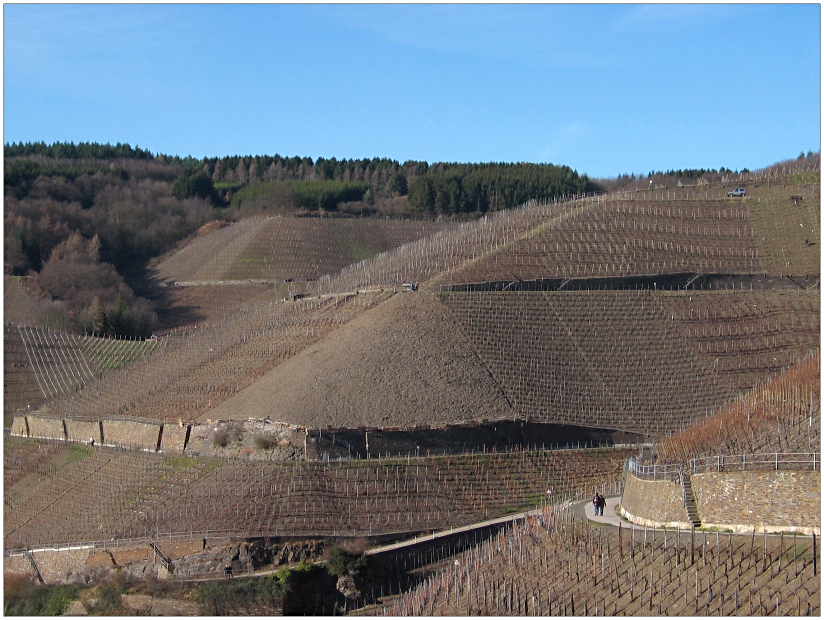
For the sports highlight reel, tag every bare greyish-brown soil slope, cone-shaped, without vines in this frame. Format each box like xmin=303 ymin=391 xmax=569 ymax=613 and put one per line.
xmin=208 ymin=293 xmax=512 ymax=428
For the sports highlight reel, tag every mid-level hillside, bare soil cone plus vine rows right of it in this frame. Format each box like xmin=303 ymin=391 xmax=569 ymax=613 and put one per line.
xmin=202 ymin=291 xmax=819 ymax=436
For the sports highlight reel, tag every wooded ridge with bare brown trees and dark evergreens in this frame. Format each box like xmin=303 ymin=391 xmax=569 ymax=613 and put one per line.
xmin=3 ymin=142 xmax=596 ymax=336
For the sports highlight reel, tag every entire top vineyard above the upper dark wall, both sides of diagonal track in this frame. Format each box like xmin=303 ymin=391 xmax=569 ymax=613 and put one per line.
xmin=292 ymin=184 xmax=820 ymax=292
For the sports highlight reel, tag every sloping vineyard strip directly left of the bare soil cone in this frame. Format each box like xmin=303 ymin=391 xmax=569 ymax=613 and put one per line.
xmin=41 ymin=293 xmax=389 ymax=420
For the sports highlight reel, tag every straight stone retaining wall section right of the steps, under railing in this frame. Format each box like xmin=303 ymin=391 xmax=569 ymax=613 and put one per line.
xmin=692 ymin=471 xmax=821 ymax=534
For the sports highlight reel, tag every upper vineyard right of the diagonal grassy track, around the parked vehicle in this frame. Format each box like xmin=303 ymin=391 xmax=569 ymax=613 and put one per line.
xmin=443 ymin=179 xmax=821 ymax=284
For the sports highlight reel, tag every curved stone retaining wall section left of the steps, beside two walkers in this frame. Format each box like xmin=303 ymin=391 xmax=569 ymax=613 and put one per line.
xmin=621 ymin=474 xmax=691 ymax=529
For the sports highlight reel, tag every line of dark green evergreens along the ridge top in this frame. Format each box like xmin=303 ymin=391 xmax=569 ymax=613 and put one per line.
xmin=4 ymin=142 xmax=597 ymax=217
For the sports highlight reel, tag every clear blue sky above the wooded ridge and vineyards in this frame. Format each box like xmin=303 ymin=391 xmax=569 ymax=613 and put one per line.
xmin=3 ymin=4 xmax=821 ymax=177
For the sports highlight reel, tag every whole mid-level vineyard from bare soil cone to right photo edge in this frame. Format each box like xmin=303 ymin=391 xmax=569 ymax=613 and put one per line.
xmin=442 ymin=291 xmax=819 ymax=435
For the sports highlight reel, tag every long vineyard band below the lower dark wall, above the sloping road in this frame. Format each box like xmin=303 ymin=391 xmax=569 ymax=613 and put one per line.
xmin=4 ymin=439 xmax=630 ymax=549
